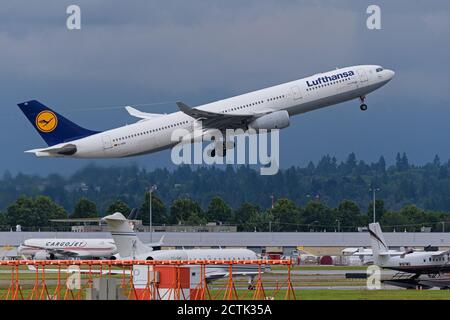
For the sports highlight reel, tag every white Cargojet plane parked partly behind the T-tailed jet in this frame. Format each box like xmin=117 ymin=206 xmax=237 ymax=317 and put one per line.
xmin=17 ymin=209 xmax=164 ymax=260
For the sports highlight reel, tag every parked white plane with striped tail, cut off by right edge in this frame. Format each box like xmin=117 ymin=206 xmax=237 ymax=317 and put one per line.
xmin=369 ymin=223 xmax=450 ymax=289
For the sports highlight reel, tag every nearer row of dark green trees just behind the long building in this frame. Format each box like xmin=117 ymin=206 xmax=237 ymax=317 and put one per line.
xmin=0 ymin=193 xmax=450 ymax=232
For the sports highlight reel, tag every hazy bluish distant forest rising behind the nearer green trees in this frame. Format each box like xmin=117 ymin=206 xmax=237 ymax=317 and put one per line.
xmin=0 ymin=153 xmax=450 ymax=212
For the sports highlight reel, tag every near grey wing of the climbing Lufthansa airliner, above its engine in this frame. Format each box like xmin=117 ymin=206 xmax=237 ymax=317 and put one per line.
xmin=177 ymin=101 xmax=270 ymax=130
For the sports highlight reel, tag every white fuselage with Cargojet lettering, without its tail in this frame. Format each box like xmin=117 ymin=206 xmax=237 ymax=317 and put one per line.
xmin=17 ymin=239 xmax=117 ymax=258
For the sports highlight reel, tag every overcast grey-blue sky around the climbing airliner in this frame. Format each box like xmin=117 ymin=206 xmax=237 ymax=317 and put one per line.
xmin=0 ymin=0 xmax=450 ymax=174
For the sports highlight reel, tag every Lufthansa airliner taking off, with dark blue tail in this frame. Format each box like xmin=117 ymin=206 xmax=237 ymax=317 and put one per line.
xmin=18 ymin=65 xmax=395 ymax=158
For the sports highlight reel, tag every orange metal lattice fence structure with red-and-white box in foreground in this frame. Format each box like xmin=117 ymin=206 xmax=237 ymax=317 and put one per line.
xmin=0 ymin=260 xmax=296 ymax=300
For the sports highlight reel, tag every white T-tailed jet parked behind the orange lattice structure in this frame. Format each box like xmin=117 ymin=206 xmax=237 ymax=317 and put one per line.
xmin=102 ymin=212 xmax=258 ymax=289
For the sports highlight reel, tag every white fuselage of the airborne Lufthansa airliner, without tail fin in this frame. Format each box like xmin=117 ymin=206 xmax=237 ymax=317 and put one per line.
xmin=36 ymin=65 xmax=394 ymax=158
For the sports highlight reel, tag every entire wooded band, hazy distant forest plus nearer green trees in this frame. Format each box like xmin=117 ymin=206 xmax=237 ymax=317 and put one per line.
xmin=0 ymin=153 xmax=450 ymax=230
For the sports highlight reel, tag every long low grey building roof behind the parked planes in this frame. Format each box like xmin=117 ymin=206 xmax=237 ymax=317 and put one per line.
xmin=0 ymin=232 xmax=450 ymax=247
